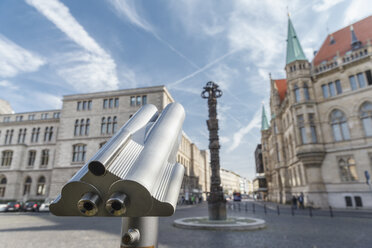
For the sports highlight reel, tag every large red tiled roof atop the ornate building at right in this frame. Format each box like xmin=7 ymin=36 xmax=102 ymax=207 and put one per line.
xmin=313 ymin=16 xmax=372 ymax=66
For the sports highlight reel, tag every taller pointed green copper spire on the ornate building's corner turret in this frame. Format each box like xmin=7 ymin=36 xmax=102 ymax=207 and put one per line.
xmin=286 ymin=16 xmax=307 ymax=65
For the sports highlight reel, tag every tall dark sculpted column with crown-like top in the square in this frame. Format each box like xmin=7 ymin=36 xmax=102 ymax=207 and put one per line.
xmin=201 ymin=81 xmax=226 ymax=220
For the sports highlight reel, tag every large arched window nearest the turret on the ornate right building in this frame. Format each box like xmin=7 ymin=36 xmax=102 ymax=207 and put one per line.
xmin=331 ymin=109 xmax=350 ymax=141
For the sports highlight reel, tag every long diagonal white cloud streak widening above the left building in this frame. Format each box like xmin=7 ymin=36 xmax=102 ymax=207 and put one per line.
xmin=26 ymin=0 xmax=118 ymax=91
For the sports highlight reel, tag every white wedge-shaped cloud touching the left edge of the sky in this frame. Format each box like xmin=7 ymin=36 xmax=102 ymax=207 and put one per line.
xmin=0 ymin=35 xmax=45 ymax=77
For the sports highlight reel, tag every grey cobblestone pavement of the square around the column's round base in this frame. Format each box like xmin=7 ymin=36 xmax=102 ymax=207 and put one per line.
xmin=0 ymin=202 xmax=372 ymax=248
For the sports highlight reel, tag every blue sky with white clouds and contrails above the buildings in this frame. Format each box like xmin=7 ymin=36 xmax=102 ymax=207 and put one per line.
xmin=0 ymin=0 xmax=372 ymax=178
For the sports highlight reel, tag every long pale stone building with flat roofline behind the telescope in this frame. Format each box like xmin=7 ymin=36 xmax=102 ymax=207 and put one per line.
xmin=0 ymin=86 xmax=209 ymax=201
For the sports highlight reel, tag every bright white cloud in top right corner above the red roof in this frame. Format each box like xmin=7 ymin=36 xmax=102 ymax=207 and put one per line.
xmin=343 ymin=0 xmax=372 ymax=26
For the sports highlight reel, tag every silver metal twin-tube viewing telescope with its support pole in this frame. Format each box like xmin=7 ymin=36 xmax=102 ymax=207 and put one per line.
xmin=50 ymin=103 xmax=185 ymax=247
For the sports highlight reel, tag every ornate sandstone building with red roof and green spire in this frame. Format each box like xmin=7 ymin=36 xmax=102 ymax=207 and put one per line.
xmin=261 ymin=16 xmax=372 ymax=208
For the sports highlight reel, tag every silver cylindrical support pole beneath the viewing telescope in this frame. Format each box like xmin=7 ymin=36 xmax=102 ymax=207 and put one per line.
xmin=120 ymin=217 xmax=159 ymax=248
